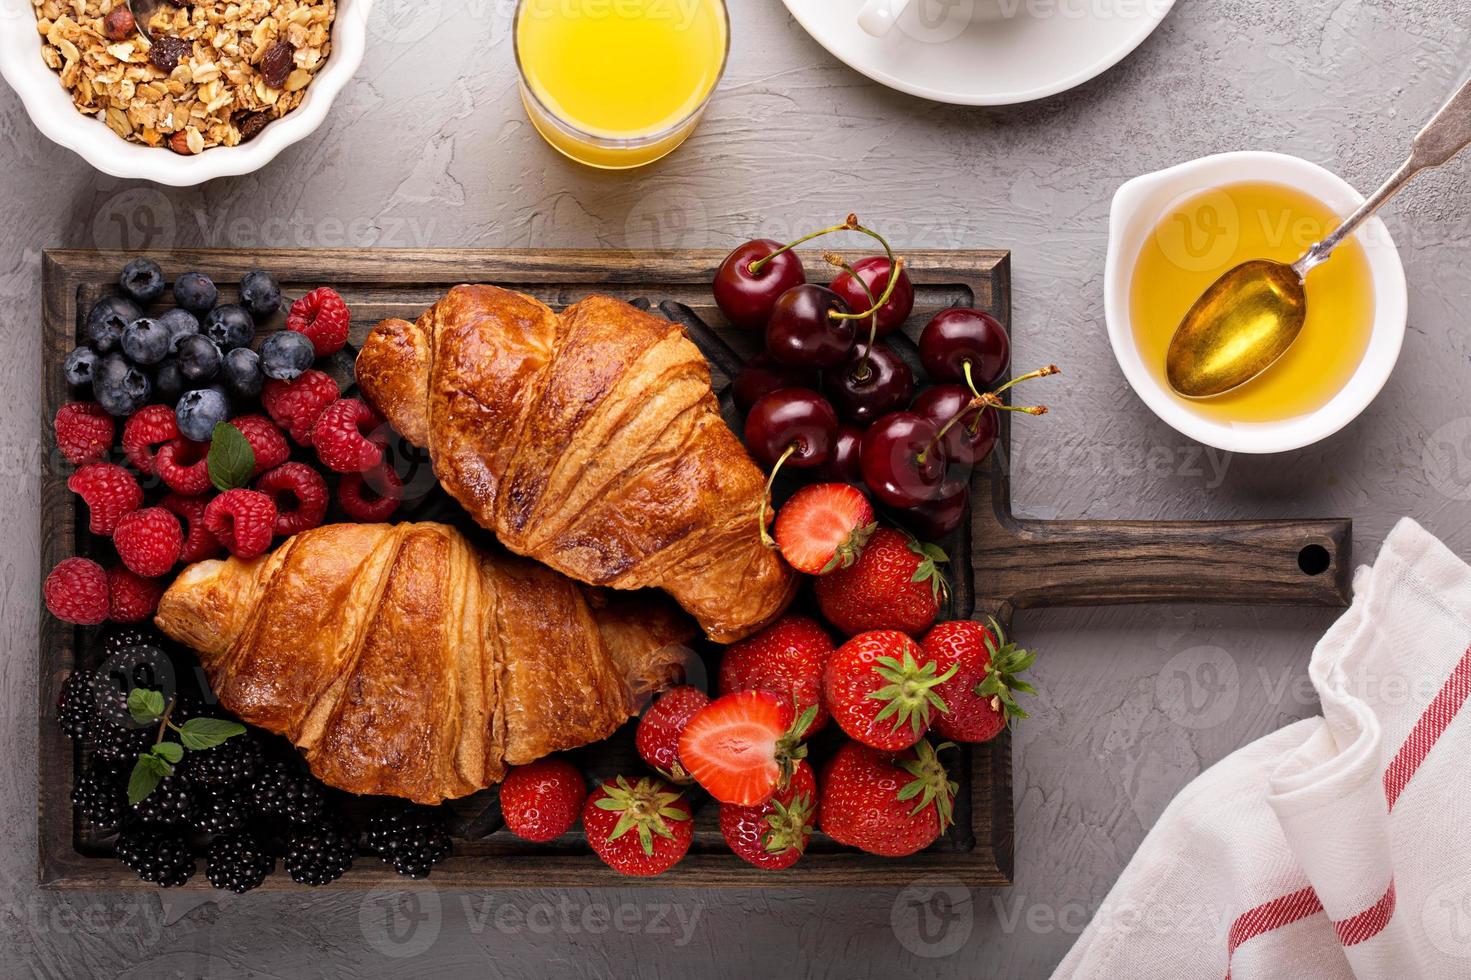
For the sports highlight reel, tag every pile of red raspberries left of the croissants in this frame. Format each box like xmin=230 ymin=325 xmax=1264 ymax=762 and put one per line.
xmin=43 ymin=287 xmax=403 ymax=625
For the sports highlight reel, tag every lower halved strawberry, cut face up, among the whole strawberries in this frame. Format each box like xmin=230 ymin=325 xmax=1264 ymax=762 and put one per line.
xmin=680 ymin=690 xmax=816 ymax=806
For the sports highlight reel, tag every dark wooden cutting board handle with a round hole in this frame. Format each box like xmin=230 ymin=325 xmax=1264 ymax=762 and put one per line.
xmin=972 ymin=515 xmax=1353 ymax=609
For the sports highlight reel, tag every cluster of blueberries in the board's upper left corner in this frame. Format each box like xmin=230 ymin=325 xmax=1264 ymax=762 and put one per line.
xmin=63 ymin=259 xmax=316 ymax=441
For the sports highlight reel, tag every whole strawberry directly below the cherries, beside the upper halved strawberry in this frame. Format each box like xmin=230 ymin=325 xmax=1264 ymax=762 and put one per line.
xmin=813 ymin=528 xmax=949 ymax=636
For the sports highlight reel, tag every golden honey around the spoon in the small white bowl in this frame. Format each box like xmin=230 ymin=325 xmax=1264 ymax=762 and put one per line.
xmin=1130 ymin=182 xmax=1374 ymax=422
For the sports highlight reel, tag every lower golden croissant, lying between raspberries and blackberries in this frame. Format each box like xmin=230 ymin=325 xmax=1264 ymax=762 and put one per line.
xmin=154 ymin=524 xmax=696 ymax=803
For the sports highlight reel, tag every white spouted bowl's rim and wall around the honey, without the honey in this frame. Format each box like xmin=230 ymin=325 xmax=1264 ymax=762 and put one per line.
xmin=1103 ymin=153 xmax=1409 ymax=453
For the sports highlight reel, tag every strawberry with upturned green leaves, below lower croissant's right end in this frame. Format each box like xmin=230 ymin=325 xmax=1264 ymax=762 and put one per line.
xmin=583 ymin=775 xmax=694 ymax=877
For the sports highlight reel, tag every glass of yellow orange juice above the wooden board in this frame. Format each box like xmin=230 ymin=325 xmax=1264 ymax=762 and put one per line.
xmin=515 ymin=0 xmax=731 ymax=171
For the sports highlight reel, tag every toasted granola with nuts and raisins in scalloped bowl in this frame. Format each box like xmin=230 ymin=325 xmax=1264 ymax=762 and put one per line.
xmin=32 ymin=0 xmax=337 ymax=155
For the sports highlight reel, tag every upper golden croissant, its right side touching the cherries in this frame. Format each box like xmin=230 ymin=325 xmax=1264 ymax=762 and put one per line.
xmin=357 ymin=285 xmax=797 ymax=643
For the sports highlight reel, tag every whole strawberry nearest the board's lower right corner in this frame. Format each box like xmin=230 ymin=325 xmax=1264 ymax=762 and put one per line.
xmin=818 ymin=742 xmax=959 ymax=858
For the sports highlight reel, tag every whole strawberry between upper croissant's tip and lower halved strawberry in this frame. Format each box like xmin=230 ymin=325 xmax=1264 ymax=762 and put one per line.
xmin=719 ymin=615 xmax=833 ymax=739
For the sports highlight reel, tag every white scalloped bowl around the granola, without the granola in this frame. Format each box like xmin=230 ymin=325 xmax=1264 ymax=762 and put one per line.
xmin=0 ymin=0 xmax=372 ymax=187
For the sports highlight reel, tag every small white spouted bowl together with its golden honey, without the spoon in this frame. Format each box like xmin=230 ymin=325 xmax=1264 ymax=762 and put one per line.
xmin=1103 ymin=153 xmax=1409 ymax=453
